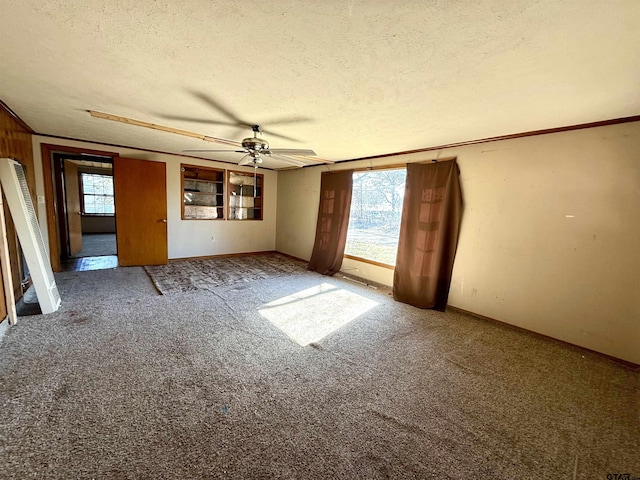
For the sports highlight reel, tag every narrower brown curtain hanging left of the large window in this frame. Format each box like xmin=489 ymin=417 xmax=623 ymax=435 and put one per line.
xmin=309 ymin=170 xmax=353 ymax=275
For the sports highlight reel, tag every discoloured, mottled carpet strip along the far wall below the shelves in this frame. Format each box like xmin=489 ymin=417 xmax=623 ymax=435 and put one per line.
xmin=144 ymin=252 xmax=306 ymax=295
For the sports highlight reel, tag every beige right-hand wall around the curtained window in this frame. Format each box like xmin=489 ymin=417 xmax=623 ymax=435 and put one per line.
xmin=276 ymin=122 xmax=640 ymax=363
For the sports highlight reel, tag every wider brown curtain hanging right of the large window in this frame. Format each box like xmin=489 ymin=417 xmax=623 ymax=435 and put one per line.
xmin=393 ymin=160 xmax=462 ymax=311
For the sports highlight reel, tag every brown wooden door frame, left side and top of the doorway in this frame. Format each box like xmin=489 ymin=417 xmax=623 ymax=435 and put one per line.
xmin=40 ymin=143 xmax=119 ymax=272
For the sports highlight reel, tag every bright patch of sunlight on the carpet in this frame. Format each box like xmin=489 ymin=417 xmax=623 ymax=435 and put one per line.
xmin=258 ymin=283 xmax=378 ymax=347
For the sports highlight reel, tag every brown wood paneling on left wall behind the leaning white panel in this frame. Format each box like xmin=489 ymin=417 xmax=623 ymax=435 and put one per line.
xmin=0 ymin=101 xmax=37 ymax=298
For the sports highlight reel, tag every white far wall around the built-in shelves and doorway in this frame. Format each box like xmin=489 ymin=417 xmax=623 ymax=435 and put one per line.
xmin=33 ymin=135 xmax=277 ymax=259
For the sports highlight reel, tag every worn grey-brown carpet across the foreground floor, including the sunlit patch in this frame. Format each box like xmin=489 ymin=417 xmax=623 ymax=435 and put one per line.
xmin=0 ymin=258 xmax=640 ymax=479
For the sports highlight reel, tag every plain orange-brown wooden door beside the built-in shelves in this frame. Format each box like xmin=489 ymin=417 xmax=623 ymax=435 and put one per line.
xmin=113 ymin=157 xmax=168 ymax=267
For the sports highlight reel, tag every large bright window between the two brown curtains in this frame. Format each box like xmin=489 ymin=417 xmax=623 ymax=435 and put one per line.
xmin=345 ymin=168 xmax=406 ymax=265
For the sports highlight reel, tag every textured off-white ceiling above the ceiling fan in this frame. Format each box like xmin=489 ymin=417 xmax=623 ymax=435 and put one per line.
xmin=0 ymin=0 xmax=640 ymax=168
